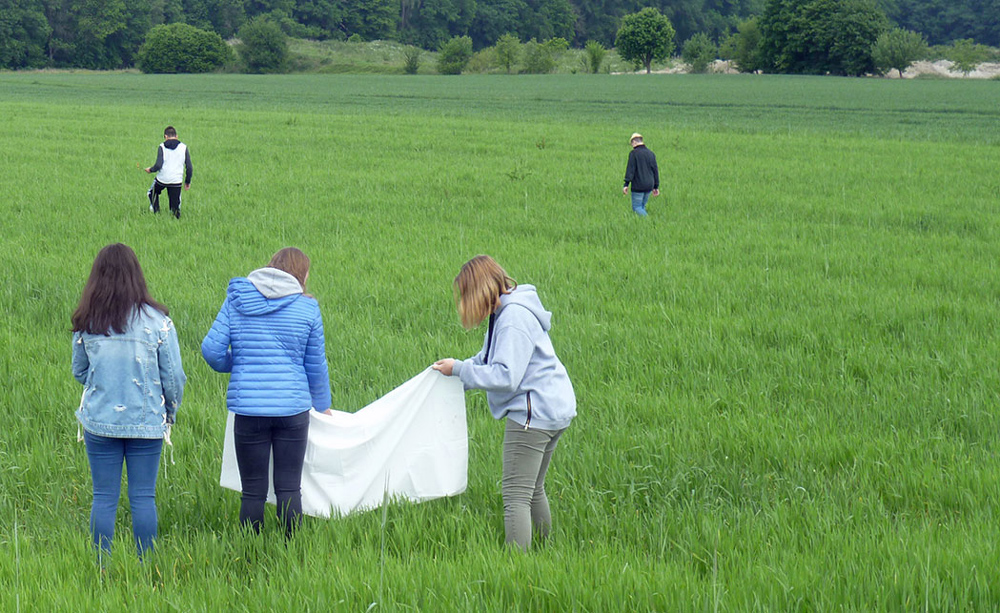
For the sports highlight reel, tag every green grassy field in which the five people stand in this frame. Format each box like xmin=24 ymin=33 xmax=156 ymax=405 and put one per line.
xmin=0 ymin=73 xmax=1000 ymax=611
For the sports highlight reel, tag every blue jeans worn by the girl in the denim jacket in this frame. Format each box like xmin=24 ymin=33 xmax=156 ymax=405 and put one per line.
xmin=83 ymin=431 xmax=163 ymax=557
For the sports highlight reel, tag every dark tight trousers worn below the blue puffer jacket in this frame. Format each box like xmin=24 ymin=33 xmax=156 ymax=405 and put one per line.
xmin=233 ymin=411 xmax=309 ymax=536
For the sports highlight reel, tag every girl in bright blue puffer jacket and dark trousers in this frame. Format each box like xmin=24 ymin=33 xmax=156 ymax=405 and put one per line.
xmin=201 ymin=247 xmax=330 ymax=536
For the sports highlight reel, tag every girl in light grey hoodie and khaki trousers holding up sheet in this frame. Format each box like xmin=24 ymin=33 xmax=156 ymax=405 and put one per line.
xmin=433 ymin=255 xmax=576 ymax=550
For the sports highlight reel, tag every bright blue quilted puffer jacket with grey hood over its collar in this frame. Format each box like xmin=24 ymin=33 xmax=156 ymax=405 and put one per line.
xmin=201 ymin=268 xmax=330 ymax=417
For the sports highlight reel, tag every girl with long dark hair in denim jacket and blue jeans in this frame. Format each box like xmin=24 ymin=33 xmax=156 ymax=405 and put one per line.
xmin=73 ymin=243 xmax=186 ymax=557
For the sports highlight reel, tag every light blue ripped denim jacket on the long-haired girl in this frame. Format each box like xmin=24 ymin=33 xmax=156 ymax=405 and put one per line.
xmin=73 ymin=306 xmax=186 ymax=438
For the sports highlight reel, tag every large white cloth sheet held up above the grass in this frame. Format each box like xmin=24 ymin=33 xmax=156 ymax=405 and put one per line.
xmin=219 ymin=368 xmax=469 ymax=517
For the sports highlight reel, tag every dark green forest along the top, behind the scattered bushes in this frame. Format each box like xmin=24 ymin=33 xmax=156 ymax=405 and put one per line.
xmin=0 ymin=0 xmax=1000 ymax=69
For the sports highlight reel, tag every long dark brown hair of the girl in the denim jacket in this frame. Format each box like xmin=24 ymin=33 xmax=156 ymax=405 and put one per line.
xmin=72 ymin=243 xmax=169 ymax=335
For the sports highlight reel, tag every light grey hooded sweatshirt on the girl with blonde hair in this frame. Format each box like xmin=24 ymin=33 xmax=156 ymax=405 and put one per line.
xmin=452 ymin=285 xmax=576 ymax=430
